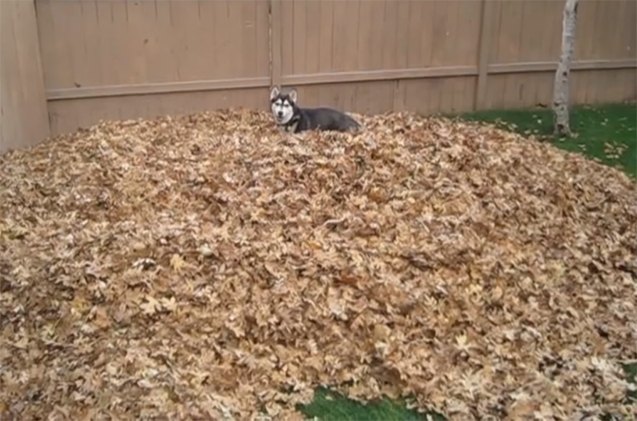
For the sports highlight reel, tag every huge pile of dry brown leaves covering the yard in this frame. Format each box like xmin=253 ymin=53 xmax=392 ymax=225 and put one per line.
xmin=0 ymin=110 xmax=637 ymax=420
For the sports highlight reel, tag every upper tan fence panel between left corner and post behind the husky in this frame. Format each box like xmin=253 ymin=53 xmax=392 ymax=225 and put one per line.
xmin=36 ymin=0 xmax=270 ymax=89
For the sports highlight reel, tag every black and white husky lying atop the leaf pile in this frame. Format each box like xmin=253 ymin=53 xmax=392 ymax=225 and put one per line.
xmin=270 ymin=86 xmax=361 ymax=133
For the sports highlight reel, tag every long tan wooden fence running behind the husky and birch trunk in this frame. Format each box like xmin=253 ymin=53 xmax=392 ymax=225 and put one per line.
xmin=0 ymin=0 xmax=637 ymax=154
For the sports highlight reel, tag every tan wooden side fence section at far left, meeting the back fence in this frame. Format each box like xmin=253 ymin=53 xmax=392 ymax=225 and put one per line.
xmin=0 ymin=0 xmax=50 ymax=153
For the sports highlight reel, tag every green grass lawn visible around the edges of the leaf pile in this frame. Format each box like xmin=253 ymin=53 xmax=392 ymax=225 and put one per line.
xmin=300 ymin=104 xmax=637 ymax=421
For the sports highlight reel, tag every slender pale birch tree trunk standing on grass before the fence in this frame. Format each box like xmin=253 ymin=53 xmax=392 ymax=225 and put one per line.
xmin=553 ymin=0 xmax=579 ymax=136
